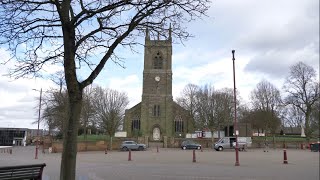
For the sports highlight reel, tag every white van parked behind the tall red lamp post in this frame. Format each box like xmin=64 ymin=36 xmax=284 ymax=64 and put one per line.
xmin=212 ymin=137 xmax=252 ymax=151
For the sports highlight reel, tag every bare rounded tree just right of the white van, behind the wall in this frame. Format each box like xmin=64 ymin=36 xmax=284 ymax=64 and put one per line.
xmin=251 ymin=80 xmax=282 ymax=134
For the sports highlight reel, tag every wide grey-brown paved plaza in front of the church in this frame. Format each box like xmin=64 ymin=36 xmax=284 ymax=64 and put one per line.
xmin=0 ymin=146 xmax=319 ymax=180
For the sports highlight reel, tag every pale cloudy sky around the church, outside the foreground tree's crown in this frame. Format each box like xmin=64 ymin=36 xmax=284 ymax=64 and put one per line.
xmin=0 ymin=0 xmax=319 ymax=129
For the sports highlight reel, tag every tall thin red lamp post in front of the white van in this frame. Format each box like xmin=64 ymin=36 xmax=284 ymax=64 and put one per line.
xmin=231 ymin=50 xmax=240 ymax=166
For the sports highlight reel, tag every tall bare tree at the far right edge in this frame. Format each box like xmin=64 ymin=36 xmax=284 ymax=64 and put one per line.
xmin=283 ymin=62 xmax=319 ymax=141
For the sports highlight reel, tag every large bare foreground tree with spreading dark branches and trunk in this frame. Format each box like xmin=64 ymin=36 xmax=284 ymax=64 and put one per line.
xmin=0 ymin=0 xmax=209 ymax=180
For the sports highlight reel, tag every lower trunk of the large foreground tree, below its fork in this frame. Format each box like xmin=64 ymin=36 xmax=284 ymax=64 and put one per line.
xmin=60 ymin=91 xmax=82 ymax=180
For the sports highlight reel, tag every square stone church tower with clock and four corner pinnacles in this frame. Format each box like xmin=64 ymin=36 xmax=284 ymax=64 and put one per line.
xmin=141 ymin=27 xmax=173 ymax=140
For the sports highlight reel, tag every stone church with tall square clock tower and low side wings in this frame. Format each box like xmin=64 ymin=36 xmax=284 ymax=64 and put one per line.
xmin=124 ymin=28 xmax=194 ymax=142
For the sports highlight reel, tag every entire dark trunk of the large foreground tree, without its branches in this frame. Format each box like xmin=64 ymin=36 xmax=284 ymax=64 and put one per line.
xmin=59 ymin=1 xmax=80 ymax=180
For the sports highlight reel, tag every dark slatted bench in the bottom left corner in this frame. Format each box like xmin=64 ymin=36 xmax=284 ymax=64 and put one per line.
xmin=0 ymin=163 xmax=46 ymax=180
